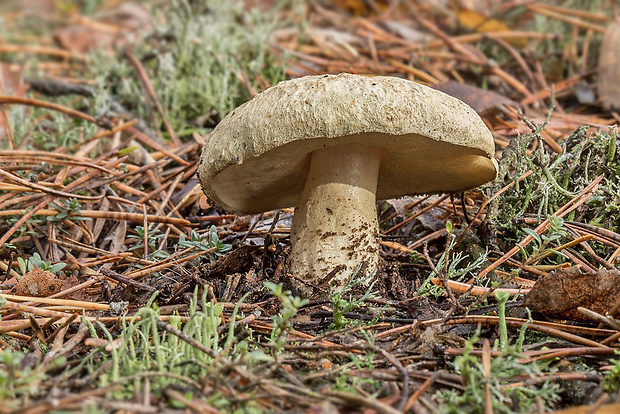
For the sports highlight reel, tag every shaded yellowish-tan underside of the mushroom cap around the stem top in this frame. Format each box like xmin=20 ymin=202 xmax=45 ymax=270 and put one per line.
xmin=202 ymin=134 xmax=496 ymax=214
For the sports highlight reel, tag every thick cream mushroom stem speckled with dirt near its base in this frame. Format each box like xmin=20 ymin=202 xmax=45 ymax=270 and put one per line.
xmin=290 ymin=144 xmax=382 ymax=297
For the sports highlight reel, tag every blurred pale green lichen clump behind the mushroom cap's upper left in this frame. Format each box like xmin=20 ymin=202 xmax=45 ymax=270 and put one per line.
xmin=93 ymin=0 xmax=288 ymax=138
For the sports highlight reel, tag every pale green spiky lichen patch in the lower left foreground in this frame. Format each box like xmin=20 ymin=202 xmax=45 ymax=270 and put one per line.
xmin=61 ymin=289 xmax=273 ymax=412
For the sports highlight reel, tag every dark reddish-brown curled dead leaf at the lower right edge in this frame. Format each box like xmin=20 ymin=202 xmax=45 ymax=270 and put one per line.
xmin=523 ymin=267 xmax=620 ymax=321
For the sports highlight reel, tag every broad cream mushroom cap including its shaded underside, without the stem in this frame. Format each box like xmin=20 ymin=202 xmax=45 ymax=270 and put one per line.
xmin=198 ymin=73 xmax=497 ymax=214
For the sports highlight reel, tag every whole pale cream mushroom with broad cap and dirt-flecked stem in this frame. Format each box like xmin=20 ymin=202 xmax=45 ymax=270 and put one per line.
xmin=198 ymin=73 xmax=497 ymax=297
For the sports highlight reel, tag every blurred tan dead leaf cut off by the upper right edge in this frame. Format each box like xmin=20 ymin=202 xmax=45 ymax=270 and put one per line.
xmin=597 ymin=21 xmax=620 ymax=109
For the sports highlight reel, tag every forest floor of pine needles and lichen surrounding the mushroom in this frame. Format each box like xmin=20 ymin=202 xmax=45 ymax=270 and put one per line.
xmin=0 ymin=0 xmax=620 ymax=413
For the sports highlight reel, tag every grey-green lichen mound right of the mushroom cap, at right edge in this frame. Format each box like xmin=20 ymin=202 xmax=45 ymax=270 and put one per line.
xmin=489 ymin=127 xmax=620 ymax=249
